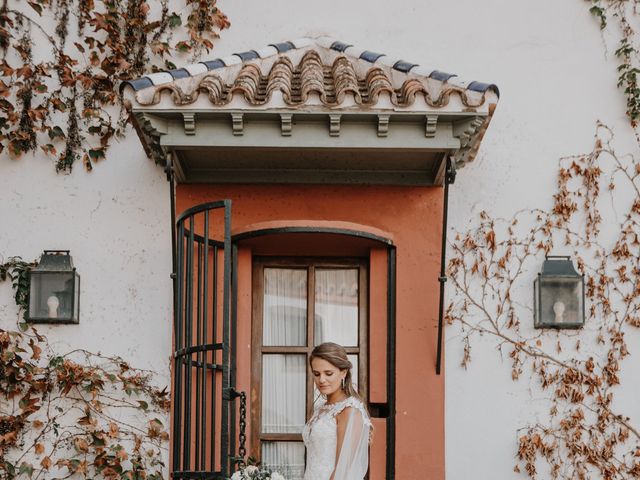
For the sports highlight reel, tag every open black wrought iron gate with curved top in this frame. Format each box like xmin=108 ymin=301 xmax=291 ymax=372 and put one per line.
xmin=172 ymin=200 xmax=243 ymax=479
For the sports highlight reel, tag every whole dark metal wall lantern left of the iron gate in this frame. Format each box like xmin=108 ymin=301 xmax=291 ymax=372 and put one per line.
xmin=27 ymin=250 xmax=80 ymax=323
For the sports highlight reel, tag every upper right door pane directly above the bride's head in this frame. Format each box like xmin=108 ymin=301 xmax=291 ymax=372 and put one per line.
xmin=314 ymin=268 xmax=359 ymax=347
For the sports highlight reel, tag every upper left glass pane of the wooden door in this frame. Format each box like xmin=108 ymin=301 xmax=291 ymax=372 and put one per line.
xmin=262 ymin=268 xmax=307 ymax=346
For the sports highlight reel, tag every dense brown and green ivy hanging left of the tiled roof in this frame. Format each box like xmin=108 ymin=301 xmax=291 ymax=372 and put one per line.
xmin=0 ymin=0 xmax=230 ymax=172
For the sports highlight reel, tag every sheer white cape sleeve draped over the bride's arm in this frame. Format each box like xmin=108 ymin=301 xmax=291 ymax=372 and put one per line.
xmin=332 ymin=399 xmax=371 ymax=480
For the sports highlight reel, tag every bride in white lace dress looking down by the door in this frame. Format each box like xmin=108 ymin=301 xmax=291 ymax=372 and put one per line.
xmin=302 ymin=343 xmax=372 ymax=480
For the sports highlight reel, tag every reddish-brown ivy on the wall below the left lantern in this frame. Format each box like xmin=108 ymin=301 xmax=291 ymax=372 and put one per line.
xmin=0 ymin=257 xmax=170 ymax=480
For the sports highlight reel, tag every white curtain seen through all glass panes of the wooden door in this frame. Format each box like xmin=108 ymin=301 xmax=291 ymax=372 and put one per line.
xmin=262 ymin=268 xmax=358 ymax=480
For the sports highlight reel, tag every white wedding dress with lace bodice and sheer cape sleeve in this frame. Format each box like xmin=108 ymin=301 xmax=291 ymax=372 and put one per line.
xmin=302 ymin=397 xmax=371 ymax=480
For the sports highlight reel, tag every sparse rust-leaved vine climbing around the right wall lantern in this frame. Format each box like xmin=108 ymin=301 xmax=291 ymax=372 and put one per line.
xmin=447 ymin=124 xmax=640 ymax=480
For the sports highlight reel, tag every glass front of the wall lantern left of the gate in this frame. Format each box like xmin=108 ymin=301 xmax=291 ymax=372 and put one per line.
xmin=29 ymin=272 xmax=79 ymax=321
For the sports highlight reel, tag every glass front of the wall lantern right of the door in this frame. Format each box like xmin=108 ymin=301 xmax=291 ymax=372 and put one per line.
xmin=539 ymin=276 xmax=584 ymax=327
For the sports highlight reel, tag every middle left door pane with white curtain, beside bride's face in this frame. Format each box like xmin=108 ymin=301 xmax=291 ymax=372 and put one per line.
xmin=262 ymin=354 xmax=306 ymax=433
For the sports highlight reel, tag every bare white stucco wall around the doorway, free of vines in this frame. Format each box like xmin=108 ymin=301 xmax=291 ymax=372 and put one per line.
xmin=0 ymin=0 xmax=640 ymax=480
